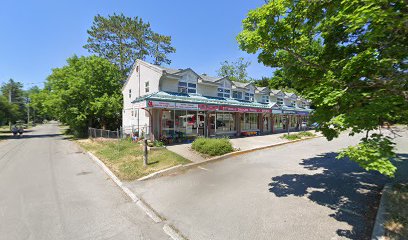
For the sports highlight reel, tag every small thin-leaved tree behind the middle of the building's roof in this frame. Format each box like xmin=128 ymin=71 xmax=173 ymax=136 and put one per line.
xmin=217 ymin=58 xmax=251 ymax=82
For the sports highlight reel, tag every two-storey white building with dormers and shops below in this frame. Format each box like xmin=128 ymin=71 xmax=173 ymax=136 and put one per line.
xmin=122 ymin=60 xmax=311 ymax=142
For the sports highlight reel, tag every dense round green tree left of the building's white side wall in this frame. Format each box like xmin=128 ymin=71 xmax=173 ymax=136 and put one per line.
xmin=39 ymin=56 xmax=122 ymax=136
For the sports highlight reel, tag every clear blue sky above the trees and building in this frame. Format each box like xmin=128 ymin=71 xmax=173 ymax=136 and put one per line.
xmin=0 ymin=0 xmax=272 ymax=88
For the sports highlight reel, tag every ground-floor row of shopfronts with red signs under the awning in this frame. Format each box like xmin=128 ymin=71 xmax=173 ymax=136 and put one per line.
xmin=135 ymin=100 xmax=307 ymax=143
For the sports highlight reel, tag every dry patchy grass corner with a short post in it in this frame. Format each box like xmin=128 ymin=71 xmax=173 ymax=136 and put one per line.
xmin=77 ymin=139 xmax=190 ymax=180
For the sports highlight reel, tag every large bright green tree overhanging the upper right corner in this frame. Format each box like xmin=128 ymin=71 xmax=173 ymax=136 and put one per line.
xmin=237 ymin=0 xmax=408 ymax=176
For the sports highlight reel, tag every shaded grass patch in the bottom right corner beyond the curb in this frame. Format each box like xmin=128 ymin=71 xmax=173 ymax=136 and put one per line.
xmin=384 ymin=183 xmax=408 ymax=239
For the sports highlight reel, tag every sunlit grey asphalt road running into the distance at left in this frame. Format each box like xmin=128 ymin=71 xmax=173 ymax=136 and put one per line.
xmin=0 ymin=124 xmax=168 ymax=240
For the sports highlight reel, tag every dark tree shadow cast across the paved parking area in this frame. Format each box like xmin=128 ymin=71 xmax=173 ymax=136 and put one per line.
xmin=269 ymin=152 xmax=408 ymax=239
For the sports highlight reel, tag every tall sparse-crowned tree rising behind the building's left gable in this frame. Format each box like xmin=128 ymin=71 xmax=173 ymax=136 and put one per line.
xmin=84 ymin=14 xmax=175 ymax=77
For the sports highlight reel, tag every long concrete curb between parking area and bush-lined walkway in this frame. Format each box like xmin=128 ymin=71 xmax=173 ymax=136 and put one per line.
xmin=137 ymin=136 xmax=323 ymax=181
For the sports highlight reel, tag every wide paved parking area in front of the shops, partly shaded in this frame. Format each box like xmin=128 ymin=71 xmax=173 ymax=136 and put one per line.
xmin=128 ymin=131 xmax=408 ymax=240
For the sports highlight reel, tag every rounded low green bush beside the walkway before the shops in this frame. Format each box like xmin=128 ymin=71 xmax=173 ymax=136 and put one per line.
xmin=191 ymin=137 xmax=234 ymax=156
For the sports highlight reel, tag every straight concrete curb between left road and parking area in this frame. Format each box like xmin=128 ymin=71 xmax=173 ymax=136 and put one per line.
xmin=86 ymin=152 xmax=186 ymax=240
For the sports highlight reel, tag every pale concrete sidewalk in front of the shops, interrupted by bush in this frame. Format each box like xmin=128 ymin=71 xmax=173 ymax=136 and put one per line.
xmin=167 ymin=131 xmax=315 ymax=163
